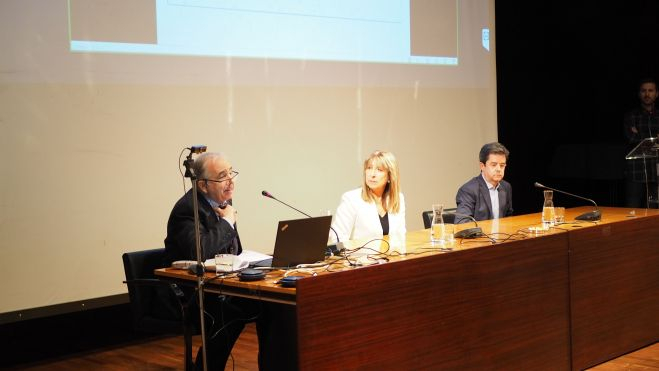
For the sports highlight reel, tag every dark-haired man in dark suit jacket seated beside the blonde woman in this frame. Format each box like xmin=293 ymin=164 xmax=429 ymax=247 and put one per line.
xmin=455 ymin=142 xmax=513 ymax=223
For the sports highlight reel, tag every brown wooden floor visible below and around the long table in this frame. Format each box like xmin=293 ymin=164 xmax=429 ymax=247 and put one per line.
xmin=10 ymin=324 xmax=659 ymax=371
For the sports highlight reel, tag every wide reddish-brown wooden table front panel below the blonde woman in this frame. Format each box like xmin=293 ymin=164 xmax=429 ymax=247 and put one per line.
xmin=297 ymin=233 xmax=570 ymax=370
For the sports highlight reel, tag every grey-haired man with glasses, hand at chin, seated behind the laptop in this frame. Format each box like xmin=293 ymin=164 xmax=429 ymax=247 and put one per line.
xmin=164 ymin=152 xmax=249 ymax=370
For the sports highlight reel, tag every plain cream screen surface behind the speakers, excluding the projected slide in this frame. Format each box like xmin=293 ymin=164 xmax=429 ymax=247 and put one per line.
xmin=0 ymin=0 xmax=497 ymax=313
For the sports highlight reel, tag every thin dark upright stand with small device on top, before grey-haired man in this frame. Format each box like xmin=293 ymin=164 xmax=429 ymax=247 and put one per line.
xmin=183 ymin=147 xmax=208 ymax=371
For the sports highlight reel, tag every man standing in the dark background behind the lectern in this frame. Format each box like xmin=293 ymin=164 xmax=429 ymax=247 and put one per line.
xmin=624 ymin=78 xmax=659 ymax=208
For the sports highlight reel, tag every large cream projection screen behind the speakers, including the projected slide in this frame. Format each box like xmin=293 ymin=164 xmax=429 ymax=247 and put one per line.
xmin=0 ymin=0 xmax=497 ymax=320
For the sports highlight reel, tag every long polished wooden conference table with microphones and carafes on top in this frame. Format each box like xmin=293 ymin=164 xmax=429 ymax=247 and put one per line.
xmin=156 ymin=208 xmax=659 ymax=370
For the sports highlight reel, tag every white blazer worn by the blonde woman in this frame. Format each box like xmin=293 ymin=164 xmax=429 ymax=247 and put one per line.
xmin=330 ymin=188 xmax=406 ymax=242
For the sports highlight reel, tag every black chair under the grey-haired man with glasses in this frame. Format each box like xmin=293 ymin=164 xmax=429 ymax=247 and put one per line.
xmin=122 ymin=248 xmax=197 ymax=370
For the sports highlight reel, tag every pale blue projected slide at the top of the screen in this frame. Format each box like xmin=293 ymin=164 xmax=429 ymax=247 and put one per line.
xmin=69 ymin=0 xmax=459 ymax=65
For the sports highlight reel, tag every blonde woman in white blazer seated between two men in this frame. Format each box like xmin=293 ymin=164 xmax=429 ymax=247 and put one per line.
xmin=330 ymin=151 xmax=406 ymax=241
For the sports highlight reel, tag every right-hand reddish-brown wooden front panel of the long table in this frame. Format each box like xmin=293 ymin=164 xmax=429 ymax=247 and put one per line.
xmin=569 ymin=211 xmax=659 ymax=370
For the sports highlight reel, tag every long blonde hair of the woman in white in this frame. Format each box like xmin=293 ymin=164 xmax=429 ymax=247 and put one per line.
xmin=362 ymin=151 xmax=400 ymax=213
